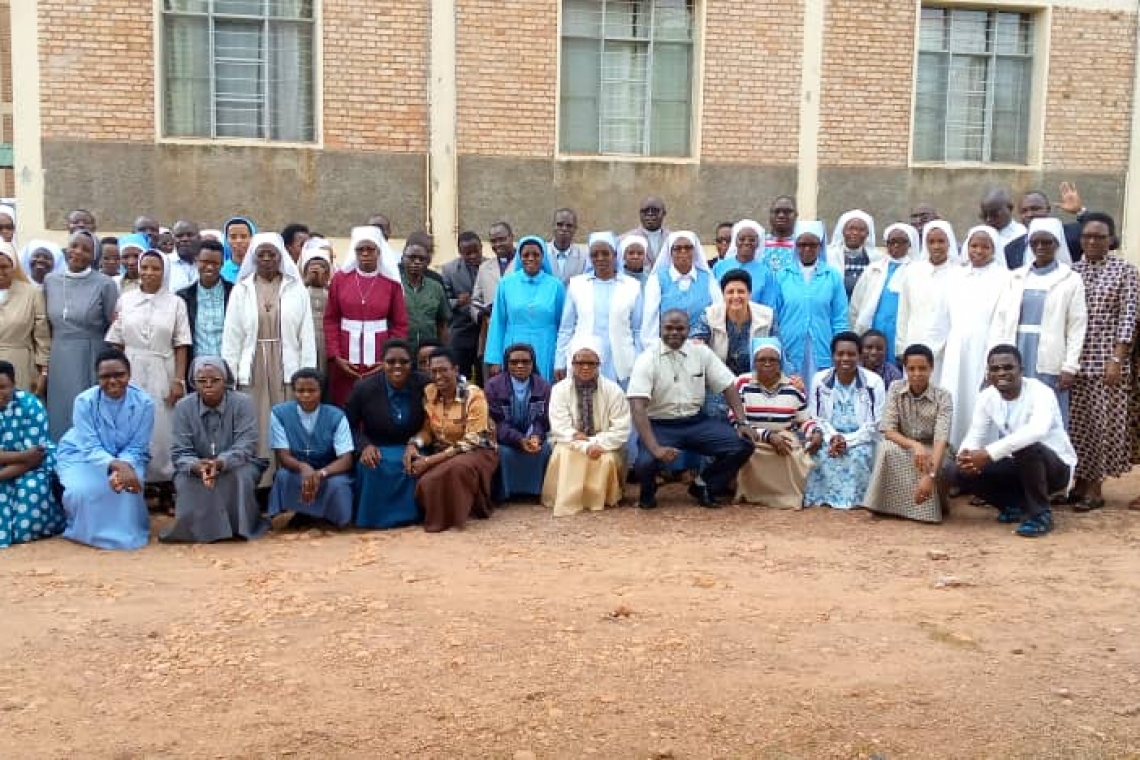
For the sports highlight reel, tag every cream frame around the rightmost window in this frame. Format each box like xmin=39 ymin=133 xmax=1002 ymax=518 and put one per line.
xmin=907 ymin=0 xmax=1052 ymax=171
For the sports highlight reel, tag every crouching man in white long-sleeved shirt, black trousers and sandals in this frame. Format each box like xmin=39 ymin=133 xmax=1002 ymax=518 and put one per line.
xmin=952 ymin=344 xmax=1076 ymax=538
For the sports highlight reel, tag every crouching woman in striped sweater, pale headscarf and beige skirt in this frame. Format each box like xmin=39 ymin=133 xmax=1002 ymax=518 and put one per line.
xmin=736 ymin=337 xmax=823 ymax=509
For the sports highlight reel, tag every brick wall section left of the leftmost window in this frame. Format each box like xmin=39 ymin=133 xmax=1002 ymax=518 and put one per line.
xmin=36 ymin=0 xmax=155 ymax=141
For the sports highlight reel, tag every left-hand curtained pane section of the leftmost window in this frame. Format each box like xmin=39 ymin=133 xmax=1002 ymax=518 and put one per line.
xmin=163 ymin=16 xmax=211 ymax=137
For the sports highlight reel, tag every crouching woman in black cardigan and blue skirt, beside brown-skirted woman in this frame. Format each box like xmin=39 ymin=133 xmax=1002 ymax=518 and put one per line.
xmin=344 ymin=338 xmax=430 ymax=528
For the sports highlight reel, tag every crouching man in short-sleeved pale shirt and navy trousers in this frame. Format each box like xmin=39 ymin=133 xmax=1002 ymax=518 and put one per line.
xmin=626 ymin=309 xmax=759 ymax=509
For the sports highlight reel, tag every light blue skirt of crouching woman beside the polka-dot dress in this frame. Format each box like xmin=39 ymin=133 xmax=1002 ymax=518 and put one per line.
xmin=57 ymin=463 xmax=150 ymax=549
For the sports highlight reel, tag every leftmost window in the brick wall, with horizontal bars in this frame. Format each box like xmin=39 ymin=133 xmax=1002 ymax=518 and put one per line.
xmin=162 ymin=0 xmax=315 ymax=142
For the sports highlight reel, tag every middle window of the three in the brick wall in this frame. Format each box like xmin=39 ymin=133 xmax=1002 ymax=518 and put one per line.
xmin=559 ymin=0 xmax=694 ymax=156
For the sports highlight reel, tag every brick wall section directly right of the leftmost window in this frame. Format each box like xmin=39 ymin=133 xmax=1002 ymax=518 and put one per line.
xmin=321 ymin=0 xmax=431 ymax=153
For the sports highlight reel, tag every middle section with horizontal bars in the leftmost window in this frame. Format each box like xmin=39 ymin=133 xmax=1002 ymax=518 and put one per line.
xmin=214 ymin=19 xmax=264 ymax=138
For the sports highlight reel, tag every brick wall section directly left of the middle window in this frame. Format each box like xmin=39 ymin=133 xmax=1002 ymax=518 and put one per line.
xmin=456 ymin=0 xmax=559 ymax=157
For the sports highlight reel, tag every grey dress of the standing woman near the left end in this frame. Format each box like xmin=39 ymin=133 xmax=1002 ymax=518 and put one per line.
xmin=43 ymin=270 xmax=119 ymax=441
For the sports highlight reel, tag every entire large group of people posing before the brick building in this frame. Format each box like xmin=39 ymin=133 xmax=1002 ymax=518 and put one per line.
xmin=0 ymin=185 xmax=1140 ymax=548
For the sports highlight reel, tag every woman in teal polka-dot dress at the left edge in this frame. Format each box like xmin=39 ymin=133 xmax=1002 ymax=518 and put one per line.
xmin=0 ymin=361 xmax=64 ymax=549
